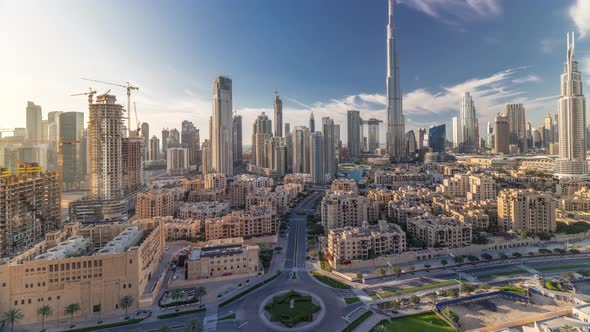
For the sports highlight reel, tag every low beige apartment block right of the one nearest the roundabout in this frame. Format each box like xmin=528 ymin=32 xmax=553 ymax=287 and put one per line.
xmin=407 ymin=214 xmax=472 ymax=247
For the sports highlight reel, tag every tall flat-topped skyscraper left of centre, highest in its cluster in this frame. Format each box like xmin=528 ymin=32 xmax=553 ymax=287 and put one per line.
xmin=211 ymin=76 xmax=234 ymax=177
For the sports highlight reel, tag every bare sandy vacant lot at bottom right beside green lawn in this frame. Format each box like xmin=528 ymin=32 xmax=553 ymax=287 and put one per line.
xmin=451 ymin=295 xmax=571 ymax=331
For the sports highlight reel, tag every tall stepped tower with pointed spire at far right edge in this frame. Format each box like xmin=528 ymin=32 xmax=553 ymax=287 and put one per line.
xmin=557 ymin=32 xmax=588 ymax=177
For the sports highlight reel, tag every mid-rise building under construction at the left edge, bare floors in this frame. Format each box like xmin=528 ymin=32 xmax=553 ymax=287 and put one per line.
xmin=0 ymin=169 xmax=61 ymax=259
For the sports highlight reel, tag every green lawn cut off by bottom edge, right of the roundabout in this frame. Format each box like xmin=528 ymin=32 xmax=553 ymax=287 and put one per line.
xmin=371 ymin=311 xmax=457 ymax=332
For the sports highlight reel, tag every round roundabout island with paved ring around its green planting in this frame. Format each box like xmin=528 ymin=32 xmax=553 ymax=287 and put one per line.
xmin=258 ymin=289 xmax=326 ymax=331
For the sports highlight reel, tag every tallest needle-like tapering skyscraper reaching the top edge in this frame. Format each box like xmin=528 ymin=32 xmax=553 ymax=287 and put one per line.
xmin=386 ymin=0 xmax=406 ymax=162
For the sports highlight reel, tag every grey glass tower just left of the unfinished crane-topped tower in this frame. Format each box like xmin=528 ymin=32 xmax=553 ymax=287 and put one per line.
xmin=59 ymin=112 xmax=86 ymax=191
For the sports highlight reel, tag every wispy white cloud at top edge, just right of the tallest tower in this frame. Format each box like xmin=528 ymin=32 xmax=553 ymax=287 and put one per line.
xmin=397 ymin=0 xmax=502 ymax=25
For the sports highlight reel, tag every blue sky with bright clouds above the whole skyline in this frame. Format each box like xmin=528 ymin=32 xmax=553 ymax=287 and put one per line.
xmin=0 ymin=0 xmax=590 ymax=142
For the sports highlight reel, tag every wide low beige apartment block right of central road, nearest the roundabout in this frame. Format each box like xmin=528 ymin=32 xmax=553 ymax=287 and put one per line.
xmin=328 ymin=220 xmax=406 ymax=262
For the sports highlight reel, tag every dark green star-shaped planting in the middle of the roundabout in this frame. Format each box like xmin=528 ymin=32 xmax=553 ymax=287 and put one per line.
xmin=264 ymin=291 xmax=320 ymax=327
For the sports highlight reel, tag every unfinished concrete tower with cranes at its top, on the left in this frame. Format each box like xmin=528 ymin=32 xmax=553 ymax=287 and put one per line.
xmin=88 ymin=94 xmax=123 ymax=200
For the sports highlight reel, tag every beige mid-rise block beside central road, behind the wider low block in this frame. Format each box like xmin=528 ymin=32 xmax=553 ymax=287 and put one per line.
xmin=321 ymin=191 xmax=369 ymax=232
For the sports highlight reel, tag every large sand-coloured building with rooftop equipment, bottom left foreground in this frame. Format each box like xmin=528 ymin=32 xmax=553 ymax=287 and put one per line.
xmin=0 ymin=220 xmax=166 ymax=326
